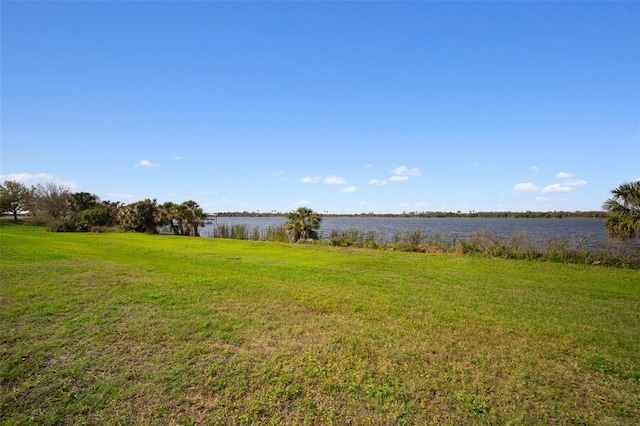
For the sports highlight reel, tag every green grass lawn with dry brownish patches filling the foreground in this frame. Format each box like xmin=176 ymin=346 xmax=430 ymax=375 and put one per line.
xmin=0 ymin=225 xmax=640 ymax=425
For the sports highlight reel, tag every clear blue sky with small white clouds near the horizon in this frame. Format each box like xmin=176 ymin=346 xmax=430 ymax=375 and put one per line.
xmin=0 ymin=2 xmax=640 ymax=213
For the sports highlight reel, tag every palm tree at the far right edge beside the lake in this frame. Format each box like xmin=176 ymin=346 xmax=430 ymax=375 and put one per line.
xmin=603 ymin=180 xmax=640 ymax=240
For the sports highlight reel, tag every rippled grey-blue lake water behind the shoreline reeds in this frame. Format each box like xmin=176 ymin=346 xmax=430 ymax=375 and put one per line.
xmin=201 ymin=217 xmax=607 ymax=246
